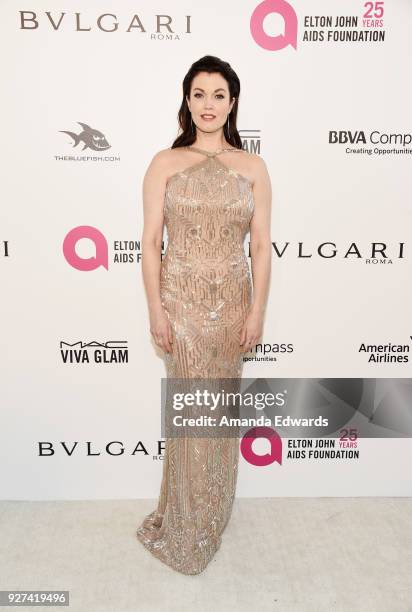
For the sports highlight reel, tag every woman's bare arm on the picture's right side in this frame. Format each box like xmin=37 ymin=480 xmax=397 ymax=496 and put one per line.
xmin=240 ymin=156 xmax=272 ymax=351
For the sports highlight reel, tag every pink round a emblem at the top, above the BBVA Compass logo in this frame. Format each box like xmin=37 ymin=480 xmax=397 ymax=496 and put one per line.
xmin=250 ymin=0 xmax=298 ymax=51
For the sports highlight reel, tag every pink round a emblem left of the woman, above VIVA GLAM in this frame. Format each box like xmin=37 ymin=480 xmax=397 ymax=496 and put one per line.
xmin=63 ymin=225 xmax=109 ymax=272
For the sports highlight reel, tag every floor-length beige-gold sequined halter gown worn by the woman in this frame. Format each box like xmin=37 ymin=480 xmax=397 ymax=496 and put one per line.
xmin=137 ymin=146 xmax=254 ymax=574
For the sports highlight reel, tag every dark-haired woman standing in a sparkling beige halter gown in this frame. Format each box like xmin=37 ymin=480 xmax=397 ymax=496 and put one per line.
xmin=137 ymin=56 xmax=271 ymax=574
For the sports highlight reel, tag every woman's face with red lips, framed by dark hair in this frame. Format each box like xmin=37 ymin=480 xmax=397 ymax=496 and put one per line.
xmin=186 ymin=72 xmax=235 ymax=132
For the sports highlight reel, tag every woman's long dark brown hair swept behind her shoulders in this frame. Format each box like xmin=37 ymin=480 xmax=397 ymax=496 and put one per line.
xmin=171 ymin=55 xmax=242 ymax=149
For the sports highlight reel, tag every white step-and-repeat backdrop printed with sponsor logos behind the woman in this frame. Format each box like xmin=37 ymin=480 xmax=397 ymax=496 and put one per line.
xmin=0 ymin=0 xmax=412 ymax=499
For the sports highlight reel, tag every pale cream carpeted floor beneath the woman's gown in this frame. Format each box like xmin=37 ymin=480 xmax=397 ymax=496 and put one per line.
xmin=0 ymin=497 xmax=412 ymax=612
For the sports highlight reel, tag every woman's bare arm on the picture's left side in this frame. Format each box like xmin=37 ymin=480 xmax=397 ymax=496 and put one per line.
xmin=142 ymin=151 xmax=172 ymax=352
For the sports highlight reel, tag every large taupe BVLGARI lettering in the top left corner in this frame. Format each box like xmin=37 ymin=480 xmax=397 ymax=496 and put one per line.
xmin=19 ymin=11 xmax=191 ymax=34
